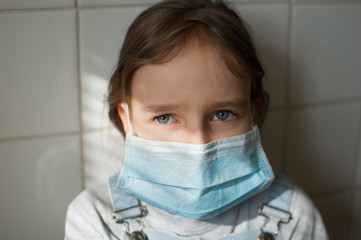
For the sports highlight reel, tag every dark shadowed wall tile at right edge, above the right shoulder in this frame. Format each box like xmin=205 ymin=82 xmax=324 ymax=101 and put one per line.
xmin=286 ymin=103 xmax=360 ymax=194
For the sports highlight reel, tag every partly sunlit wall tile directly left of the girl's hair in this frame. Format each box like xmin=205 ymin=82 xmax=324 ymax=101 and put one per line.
xmin=80 ymin=8 xmax=143 ymax=130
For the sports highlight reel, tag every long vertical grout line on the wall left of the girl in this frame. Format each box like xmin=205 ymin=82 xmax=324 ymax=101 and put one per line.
xmin=75 ymin=0 xmax=85 ymax=189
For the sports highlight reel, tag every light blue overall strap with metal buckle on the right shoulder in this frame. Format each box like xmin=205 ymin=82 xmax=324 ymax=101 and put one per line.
xmin=221 ymin=174 xmax=298 ymax=240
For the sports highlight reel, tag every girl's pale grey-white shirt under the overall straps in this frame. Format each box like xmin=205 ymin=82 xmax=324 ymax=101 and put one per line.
xmin=65 ymin=173 xmax=328 ymax=240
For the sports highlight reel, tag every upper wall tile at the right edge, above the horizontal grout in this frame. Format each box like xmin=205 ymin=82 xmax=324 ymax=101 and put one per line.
xmin=290 ymin=4 xmax=361 ymax=104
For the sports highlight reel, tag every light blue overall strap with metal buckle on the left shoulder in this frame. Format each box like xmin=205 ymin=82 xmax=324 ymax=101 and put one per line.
xmin=109 ymin=174 xmax=147 ymax=223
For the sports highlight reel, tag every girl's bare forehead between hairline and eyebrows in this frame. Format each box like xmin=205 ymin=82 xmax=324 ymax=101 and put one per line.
xmin=132 ymin=45 xmax=250 ymax=107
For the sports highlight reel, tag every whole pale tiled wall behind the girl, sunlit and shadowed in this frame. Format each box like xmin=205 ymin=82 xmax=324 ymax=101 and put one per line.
xmin=0 ymin=0 xmax=361 ymax=240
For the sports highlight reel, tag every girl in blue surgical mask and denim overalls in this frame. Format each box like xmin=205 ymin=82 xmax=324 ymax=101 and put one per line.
xmin=66 ymin=0 xmax=327 ymax=240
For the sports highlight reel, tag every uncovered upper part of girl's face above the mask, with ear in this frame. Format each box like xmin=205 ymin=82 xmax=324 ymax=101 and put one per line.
xmin=118 ymin=43 xmax=252 ymax=144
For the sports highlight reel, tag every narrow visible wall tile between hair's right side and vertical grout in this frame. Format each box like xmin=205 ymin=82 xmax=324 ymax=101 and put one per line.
xmin=238 ymin=4 xmax=288 ymax=107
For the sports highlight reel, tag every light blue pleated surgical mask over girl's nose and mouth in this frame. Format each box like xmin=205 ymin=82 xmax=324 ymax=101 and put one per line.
xmin=117 ymin=108 xmax=274 ymax=219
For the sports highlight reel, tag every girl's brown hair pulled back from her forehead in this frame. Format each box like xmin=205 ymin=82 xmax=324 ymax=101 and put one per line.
xmin=108 ymin=0 xmax=268 ymax=135
